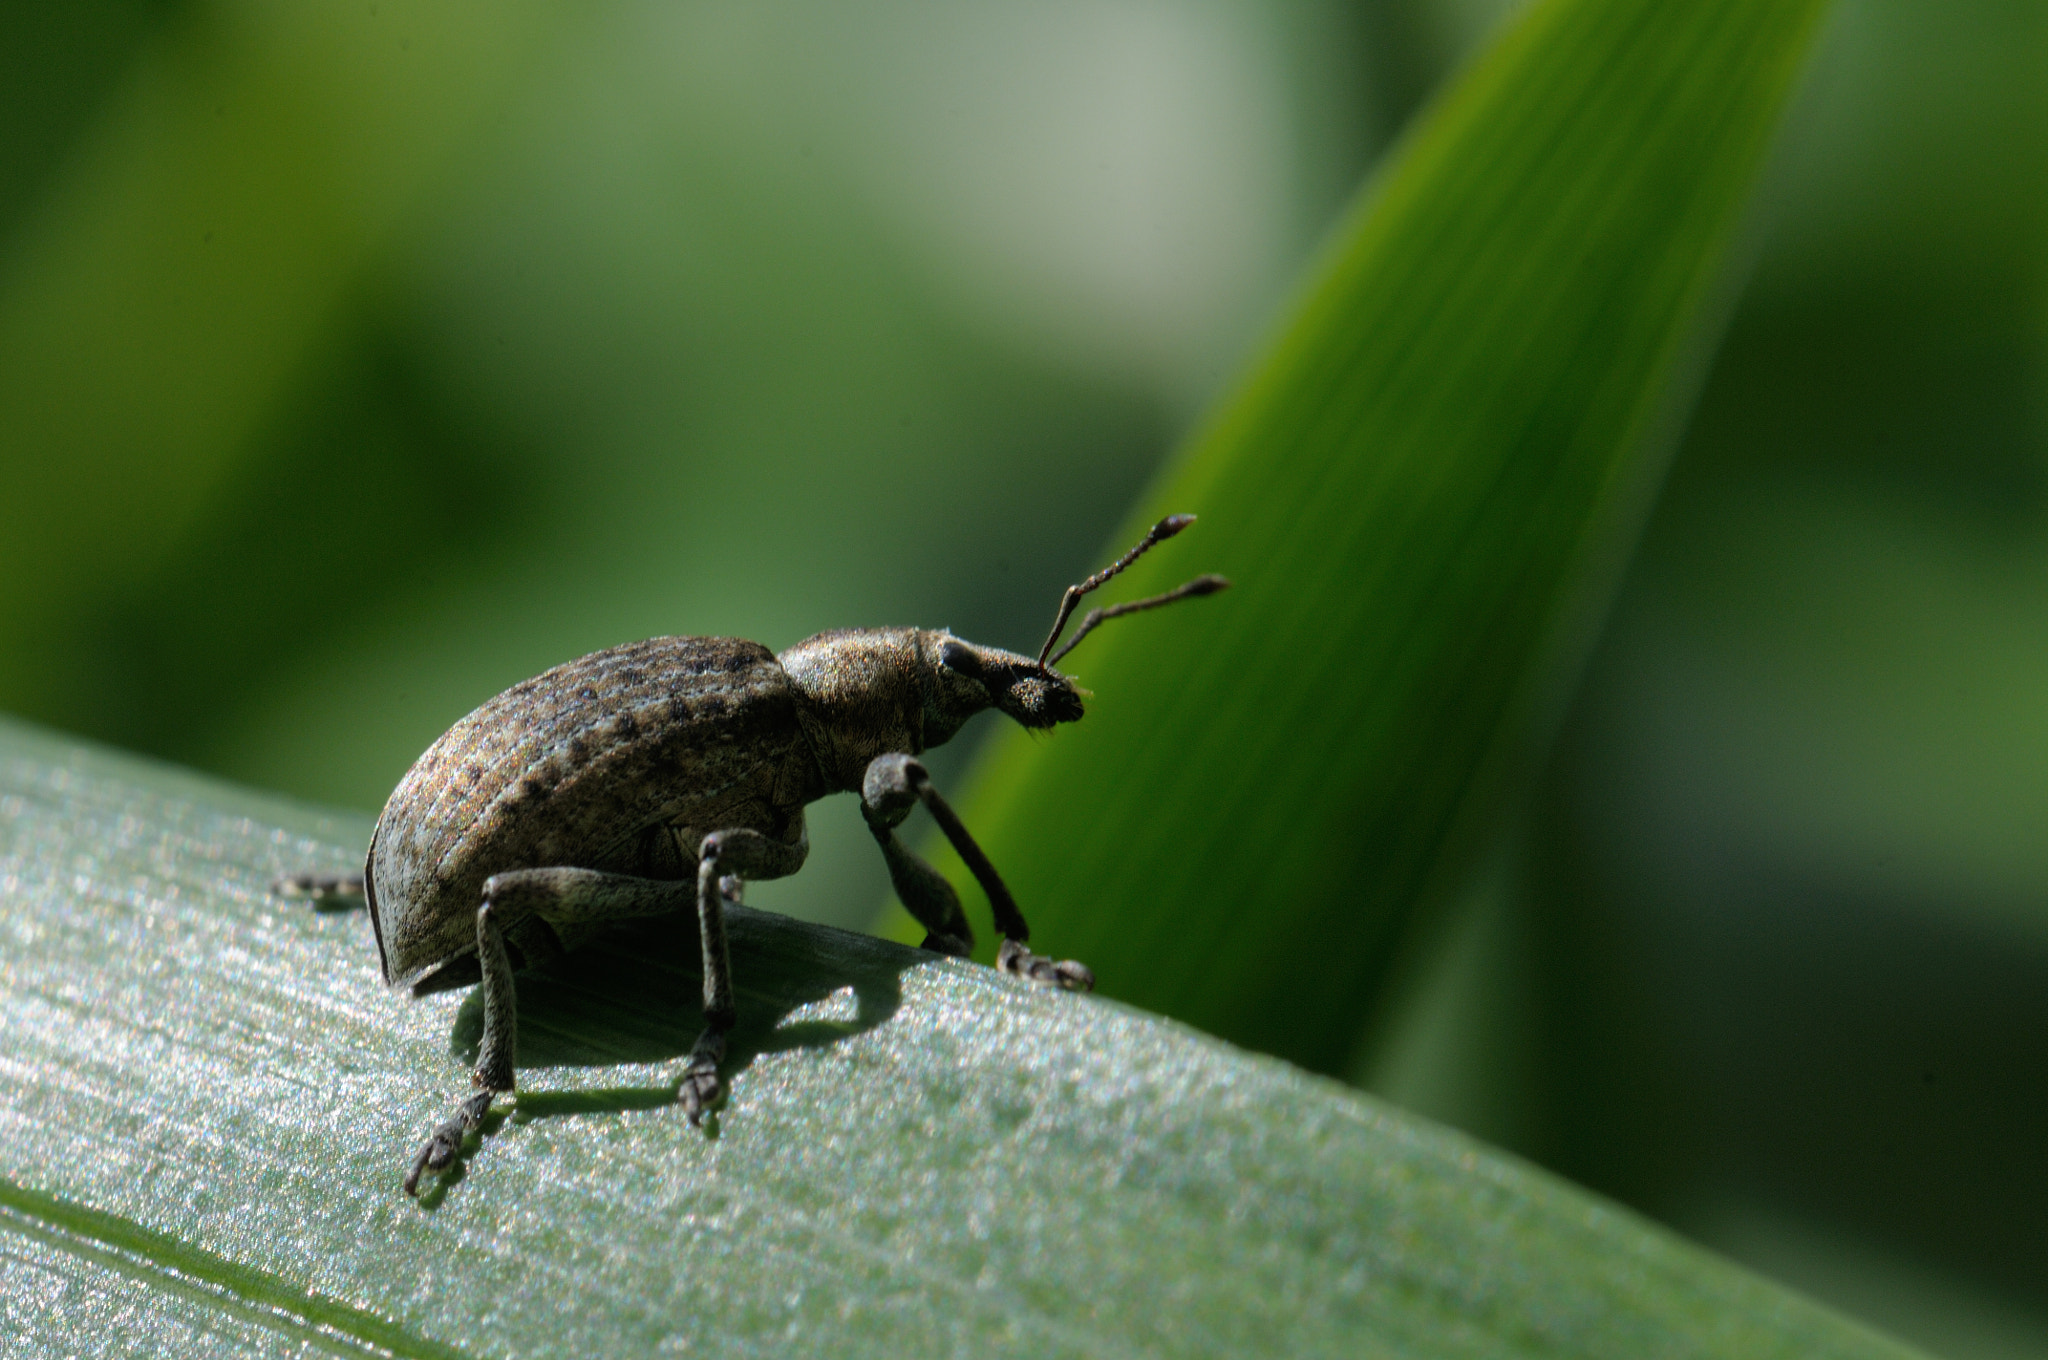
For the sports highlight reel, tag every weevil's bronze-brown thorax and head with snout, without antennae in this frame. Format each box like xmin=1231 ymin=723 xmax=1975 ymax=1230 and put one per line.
xmin=776 ymin=629 xmax=1081 ymax=791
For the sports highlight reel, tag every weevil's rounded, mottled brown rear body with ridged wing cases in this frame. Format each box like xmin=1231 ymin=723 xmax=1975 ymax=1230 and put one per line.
xmin=365 ymin=637 xmax=823 ymax=985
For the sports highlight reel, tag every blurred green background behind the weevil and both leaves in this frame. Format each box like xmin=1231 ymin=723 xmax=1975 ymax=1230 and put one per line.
xmin=0 ymin=0 xmax=2048 ymax=1356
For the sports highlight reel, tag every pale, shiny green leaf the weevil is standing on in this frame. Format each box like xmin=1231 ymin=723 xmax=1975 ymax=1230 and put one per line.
xmin=0 ymin=723 xmax=1905 ymax=1360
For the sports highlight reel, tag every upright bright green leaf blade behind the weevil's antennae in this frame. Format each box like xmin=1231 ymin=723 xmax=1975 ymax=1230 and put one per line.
xmin=888 ymin=0 xmax=1823 ymax=1071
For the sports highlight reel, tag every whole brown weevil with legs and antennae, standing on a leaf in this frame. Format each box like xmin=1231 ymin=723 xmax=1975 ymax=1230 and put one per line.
xmin=276 ymin=514 xmax=1229 ymax=1194
